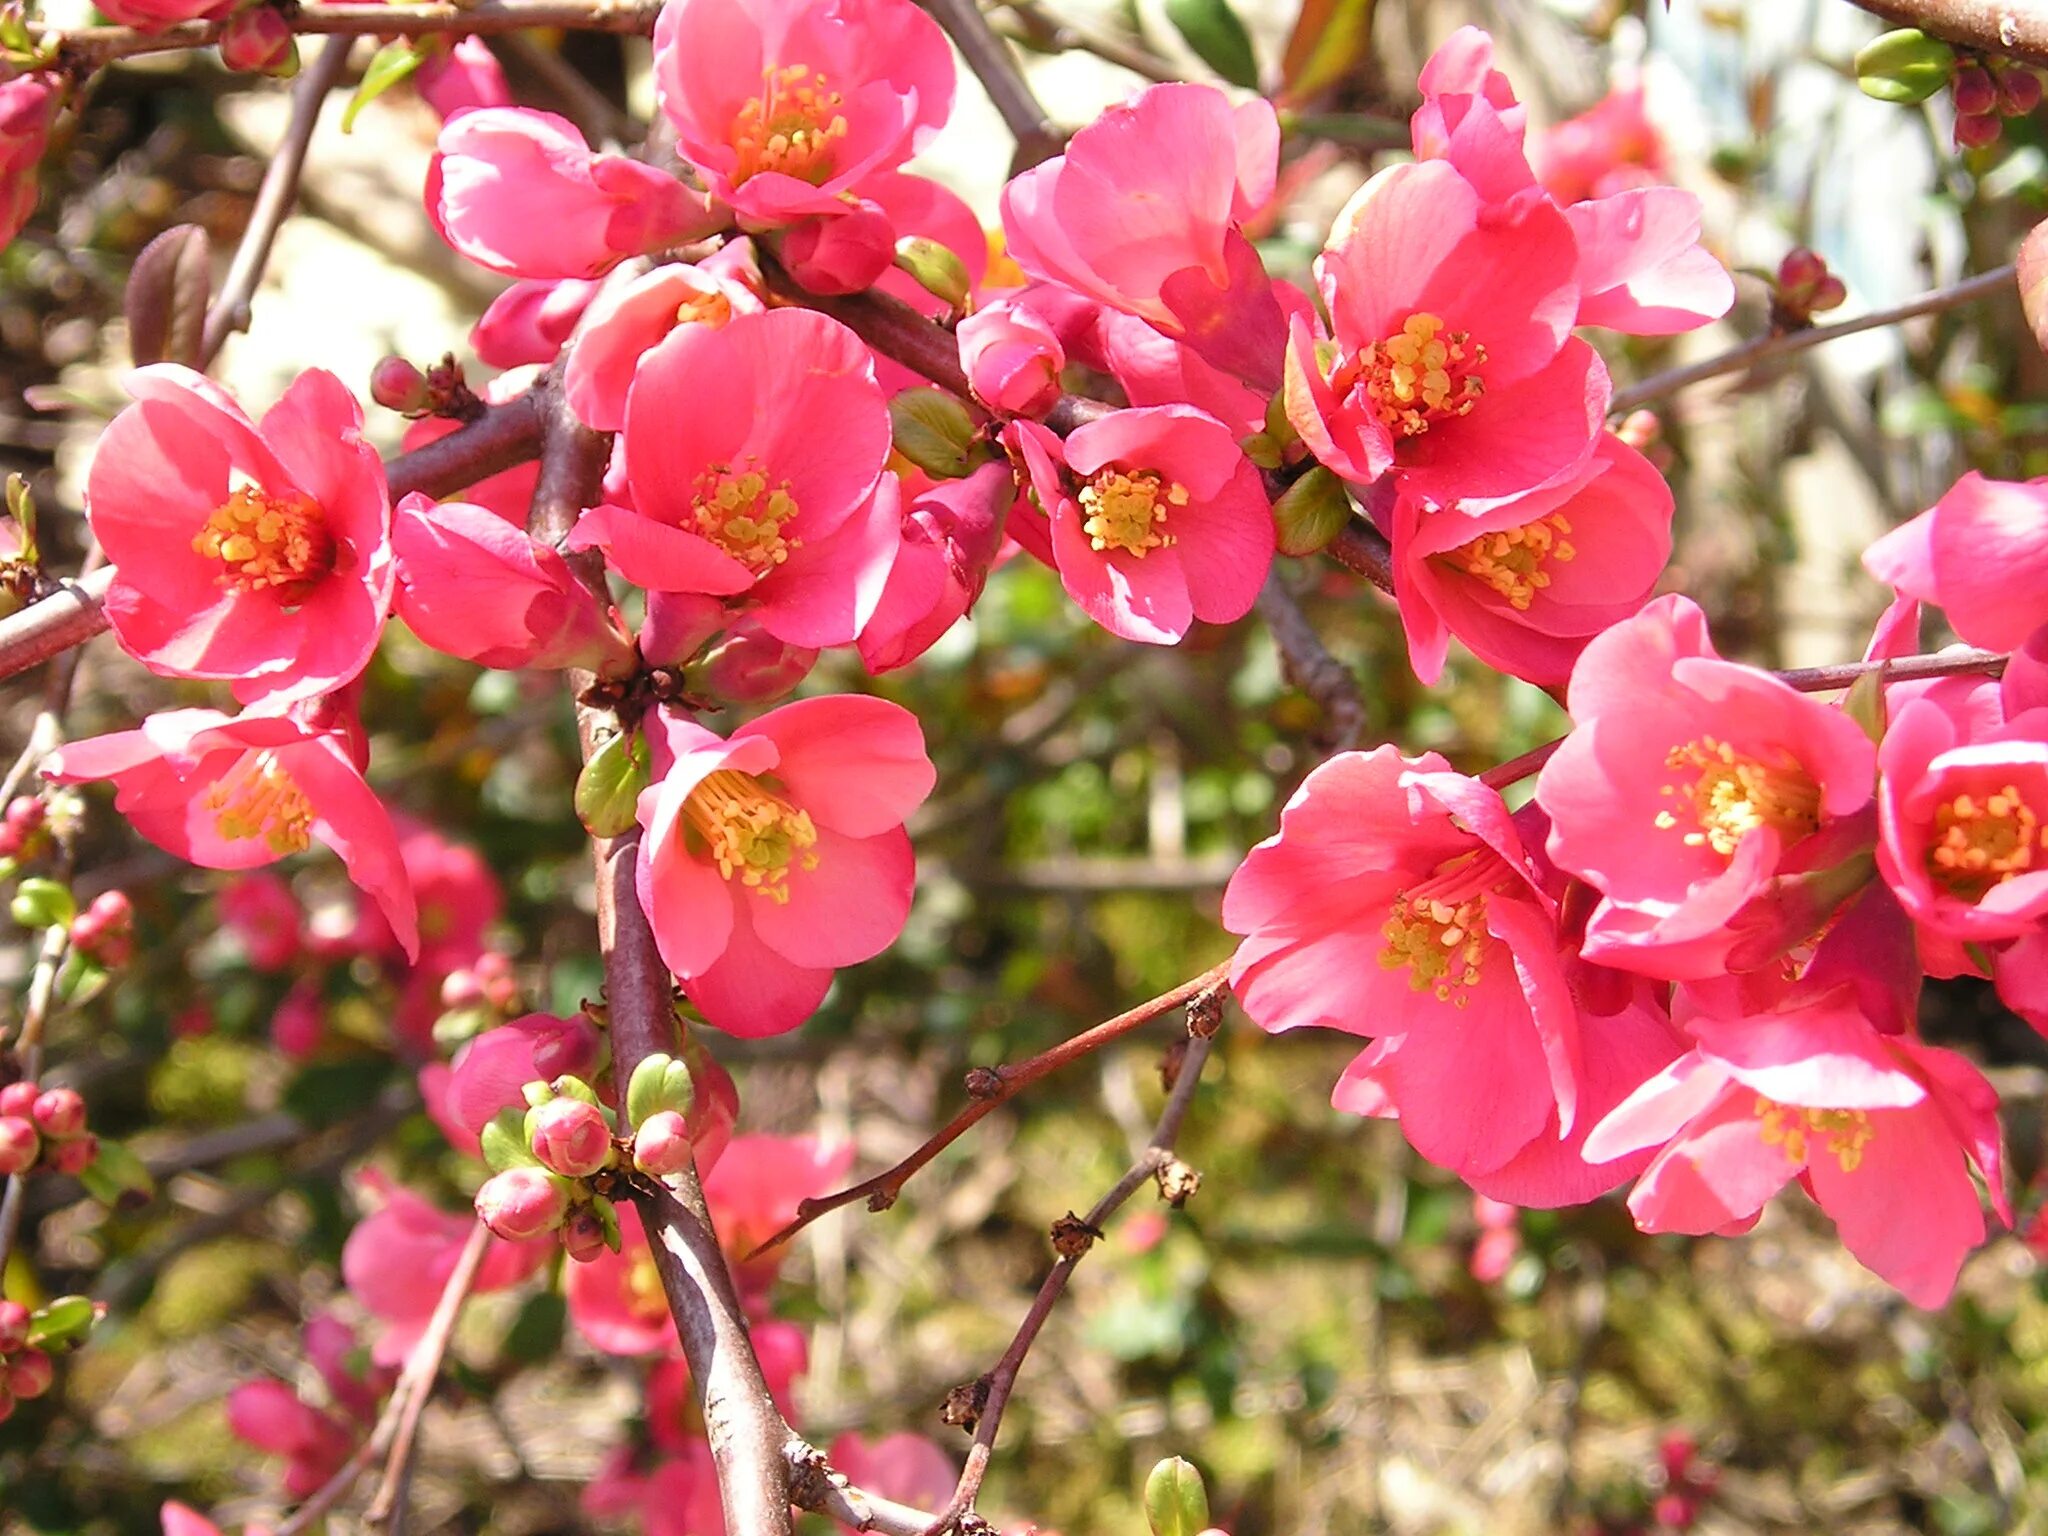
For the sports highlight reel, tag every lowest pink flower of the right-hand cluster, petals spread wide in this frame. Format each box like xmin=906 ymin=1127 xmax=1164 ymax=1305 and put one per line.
xmin=1587 ymin=989 xmax=2011 ymax=1307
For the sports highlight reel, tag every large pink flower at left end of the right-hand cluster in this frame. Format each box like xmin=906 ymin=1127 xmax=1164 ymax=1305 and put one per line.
xmin=1223 ymin=748 xmax=1579 ymax=1194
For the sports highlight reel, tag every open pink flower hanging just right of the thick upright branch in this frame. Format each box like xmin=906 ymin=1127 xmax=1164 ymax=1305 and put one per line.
xmin=637 ymin=696 xmax=932 ymax=1036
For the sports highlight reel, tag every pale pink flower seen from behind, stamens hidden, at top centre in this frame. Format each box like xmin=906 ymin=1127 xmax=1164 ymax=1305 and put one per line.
xmin=1004 ymin=84 xmax=1286 ymax=389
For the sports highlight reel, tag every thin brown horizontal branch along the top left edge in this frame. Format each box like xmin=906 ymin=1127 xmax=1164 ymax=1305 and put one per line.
xmin=31 ymin=0 xmax=662 ymax=68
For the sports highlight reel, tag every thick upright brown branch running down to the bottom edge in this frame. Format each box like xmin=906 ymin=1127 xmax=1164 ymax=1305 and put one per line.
xmin=528 ymin=393 xmax=793 ymax=1536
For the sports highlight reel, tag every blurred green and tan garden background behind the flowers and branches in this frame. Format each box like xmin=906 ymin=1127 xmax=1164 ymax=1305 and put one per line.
xmin=0 ymin=0 xmax=2048 ymax=1536
